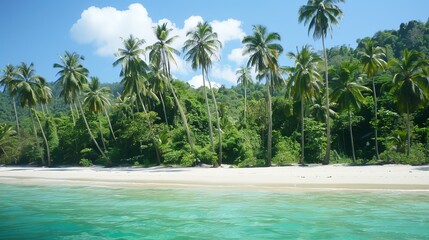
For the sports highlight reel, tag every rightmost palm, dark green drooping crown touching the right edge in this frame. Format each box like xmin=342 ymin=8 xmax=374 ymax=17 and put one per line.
xmin=391 ymin=49 xmax=429 ymax=155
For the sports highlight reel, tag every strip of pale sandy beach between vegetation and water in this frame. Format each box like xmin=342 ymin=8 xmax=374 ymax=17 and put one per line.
xmin=0 ymin=165 xmax=429 ymax=192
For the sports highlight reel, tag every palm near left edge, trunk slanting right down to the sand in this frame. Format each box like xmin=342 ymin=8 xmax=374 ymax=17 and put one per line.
xmin=14 ymin=63 xmax=51 ymax=166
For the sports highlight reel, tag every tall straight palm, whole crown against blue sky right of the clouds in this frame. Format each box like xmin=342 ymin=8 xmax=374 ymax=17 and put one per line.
xmin=242 ymin=25 xmax=283 ymax=166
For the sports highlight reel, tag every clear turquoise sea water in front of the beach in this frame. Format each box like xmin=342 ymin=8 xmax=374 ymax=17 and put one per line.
xmin=0 ymin=184 xmax=429 ymax=239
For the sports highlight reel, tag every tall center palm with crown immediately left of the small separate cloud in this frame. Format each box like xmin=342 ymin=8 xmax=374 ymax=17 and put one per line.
xmin=183 ymin=22 xmax=222 ymax=165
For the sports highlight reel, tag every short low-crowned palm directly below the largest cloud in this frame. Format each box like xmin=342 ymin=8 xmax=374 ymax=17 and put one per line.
xmin=83 ymin=77 xmax=116 ymax=149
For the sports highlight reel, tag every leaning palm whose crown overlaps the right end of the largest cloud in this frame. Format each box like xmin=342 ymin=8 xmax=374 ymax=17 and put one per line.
xmin=113 ymin=35 xmax=161 ymax=164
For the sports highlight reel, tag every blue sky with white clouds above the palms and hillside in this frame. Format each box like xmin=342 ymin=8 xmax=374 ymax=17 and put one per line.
xmin=0 ymin=0 xmax=429 ymax=86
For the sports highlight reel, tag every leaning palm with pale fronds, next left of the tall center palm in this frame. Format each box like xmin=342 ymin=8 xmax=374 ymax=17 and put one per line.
xmin=147 ymin=23 xmax=194 ymax=152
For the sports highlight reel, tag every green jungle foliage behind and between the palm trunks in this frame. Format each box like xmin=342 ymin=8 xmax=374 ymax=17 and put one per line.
xmin=0 ymin=18 xmax=429 ymax=167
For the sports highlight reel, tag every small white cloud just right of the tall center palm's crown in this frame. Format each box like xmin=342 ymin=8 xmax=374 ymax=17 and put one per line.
xmin=210 ymin=18 xmax=246 ymax=44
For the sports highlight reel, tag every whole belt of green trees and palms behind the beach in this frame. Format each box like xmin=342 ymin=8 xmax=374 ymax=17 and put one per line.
xmin=0 ymin=0 xmax=429 ymax=167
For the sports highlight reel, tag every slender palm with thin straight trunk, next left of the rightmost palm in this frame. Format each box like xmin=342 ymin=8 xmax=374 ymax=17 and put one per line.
xmin=359 ymin=41 xmax=387 ymax=160
